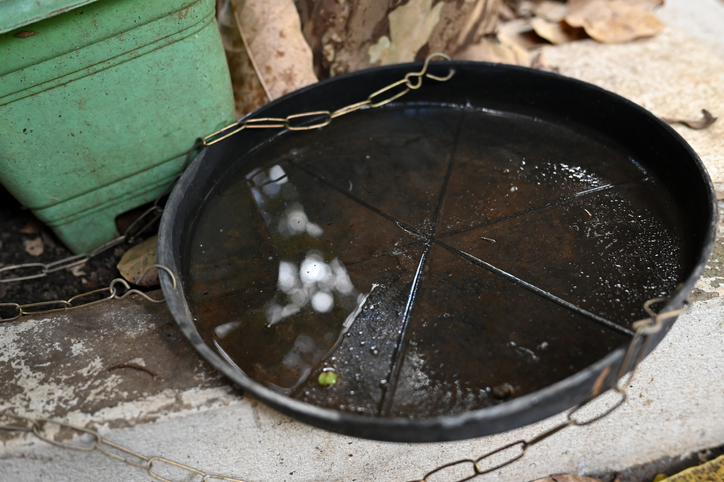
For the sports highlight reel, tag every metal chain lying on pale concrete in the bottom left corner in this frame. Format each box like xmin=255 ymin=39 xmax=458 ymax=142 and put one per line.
xmin=0 ymin=409 xmax=244 ymax=482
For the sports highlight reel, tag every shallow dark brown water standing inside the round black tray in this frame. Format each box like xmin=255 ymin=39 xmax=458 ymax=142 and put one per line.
xmin=185 ymin=106 xmax=685 ymax=418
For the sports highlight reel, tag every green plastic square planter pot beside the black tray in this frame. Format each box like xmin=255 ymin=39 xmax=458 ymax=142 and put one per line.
xmin=0 ymin=0 xmax=235 ymax=253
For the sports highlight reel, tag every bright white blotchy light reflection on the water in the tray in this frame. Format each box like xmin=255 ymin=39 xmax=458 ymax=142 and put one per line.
xmin=209 ymin=164 xmax=369 ymax=394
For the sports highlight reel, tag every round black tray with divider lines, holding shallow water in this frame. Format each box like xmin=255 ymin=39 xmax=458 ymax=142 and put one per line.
xmin=158 ymin=62 xmax=717 ymax=442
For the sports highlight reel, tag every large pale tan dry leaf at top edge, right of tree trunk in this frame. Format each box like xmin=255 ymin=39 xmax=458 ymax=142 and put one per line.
xmin=565 ymin=0 xmax=664 ymax=43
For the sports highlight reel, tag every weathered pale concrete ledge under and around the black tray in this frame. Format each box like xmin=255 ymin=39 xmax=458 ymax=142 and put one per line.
xmin=0 ymin=4 xmax=724 ymax=481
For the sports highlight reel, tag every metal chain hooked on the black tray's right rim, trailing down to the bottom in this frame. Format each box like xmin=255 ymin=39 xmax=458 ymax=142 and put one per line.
xmin=411 ymin=298 xmax=688 ymax=482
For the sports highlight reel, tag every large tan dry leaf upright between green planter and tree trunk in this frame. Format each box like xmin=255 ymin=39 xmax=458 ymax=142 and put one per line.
xmin=232 ymin=0 xmax=317 ymax=100
